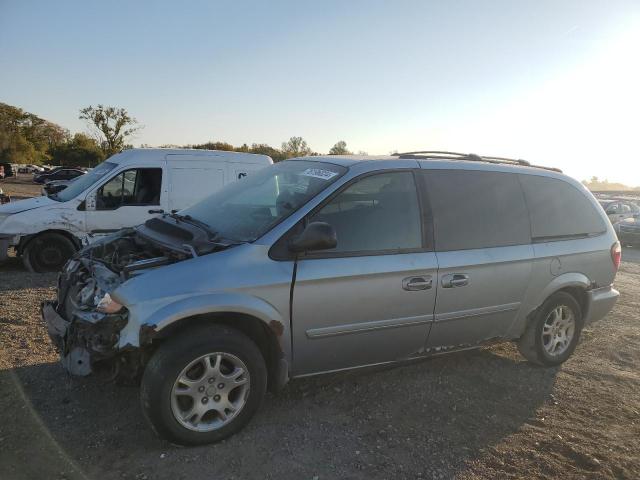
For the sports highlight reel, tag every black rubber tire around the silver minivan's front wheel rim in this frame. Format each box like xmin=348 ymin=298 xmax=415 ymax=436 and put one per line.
xmin=140 ymin=325 xmax=267 ymax=445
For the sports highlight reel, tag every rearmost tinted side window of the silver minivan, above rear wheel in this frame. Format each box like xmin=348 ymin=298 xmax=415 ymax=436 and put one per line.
xmin=520 ymin=175 xmax=606 ymax=242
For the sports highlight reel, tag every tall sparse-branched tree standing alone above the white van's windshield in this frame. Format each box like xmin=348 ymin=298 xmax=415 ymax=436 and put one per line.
xmin=79 ymin=104 xmax=142 ymax=157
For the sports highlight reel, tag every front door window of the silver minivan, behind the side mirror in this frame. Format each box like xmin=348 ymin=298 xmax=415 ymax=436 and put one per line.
xmin=309 ymin=172 xmax=422 ymax=253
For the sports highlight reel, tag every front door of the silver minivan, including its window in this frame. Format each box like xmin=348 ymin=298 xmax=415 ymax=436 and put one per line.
xmin=292 ymin=170 xmax=437 ymax=375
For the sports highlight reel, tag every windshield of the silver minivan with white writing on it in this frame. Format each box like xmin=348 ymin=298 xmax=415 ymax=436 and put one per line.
xmin=180 ymin=161 xmax=347 ymax=242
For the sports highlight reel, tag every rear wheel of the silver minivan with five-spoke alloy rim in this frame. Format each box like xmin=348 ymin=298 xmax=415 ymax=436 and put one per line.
xmin=518 ymin=292 xmax=582 ymax=366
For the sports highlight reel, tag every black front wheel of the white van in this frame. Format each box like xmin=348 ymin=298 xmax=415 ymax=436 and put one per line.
xmin=22 ymin=233 xmax=78 ymax=273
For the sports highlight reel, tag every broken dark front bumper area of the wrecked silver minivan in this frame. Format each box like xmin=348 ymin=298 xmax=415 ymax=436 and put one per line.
xmin=41 ymin=301 xmax=127 ymax=376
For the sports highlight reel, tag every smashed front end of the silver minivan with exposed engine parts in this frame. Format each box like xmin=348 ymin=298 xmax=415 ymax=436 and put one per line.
xmin=42 ymin=229 xmax=187 ymax=376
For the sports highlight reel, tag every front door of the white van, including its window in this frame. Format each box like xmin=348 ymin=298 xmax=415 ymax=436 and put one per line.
xmin=86 ymin=167 xmax=166 ymax=236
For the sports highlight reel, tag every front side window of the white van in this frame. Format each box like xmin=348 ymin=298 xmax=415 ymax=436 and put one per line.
xmin=96 ymin=168 xmax=162 ymax=210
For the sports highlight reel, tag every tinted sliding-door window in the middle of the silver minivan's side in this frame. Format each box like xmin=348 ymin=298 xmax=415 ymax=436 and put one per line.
xmin=424 ymin=170 xmax=531 ymax=251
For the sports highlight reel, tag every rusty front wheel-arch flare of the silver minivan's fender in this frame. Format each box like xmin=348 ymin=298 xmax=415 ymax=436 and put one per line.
xmin=119 ymin=292 xmax=289 ymax=349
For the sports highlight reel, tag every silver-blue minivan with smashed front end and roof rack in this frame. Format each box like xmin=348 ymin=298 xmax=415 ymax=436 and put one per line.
xmin=42 ymin=152 xmax=620 ymax=444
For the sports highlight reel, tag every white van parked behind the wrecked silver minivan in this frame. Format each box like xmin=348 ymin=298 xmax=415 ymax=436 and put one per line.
xmin=0 ymin=148 xmax=273 ymax=272
